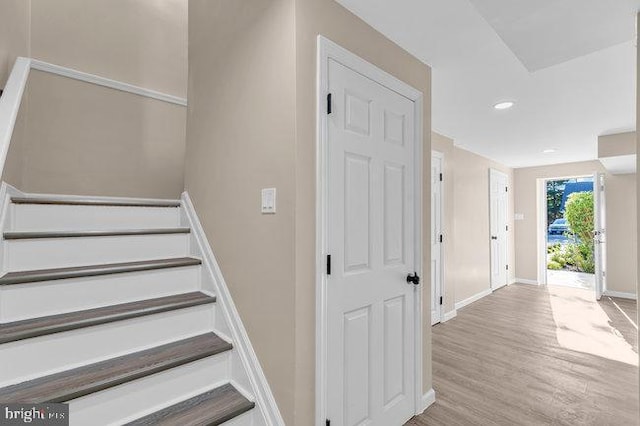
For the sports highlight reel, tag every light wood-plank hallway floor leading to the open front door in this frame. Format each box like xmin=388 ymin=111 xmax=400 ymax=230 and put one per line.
xmin=407 ymin=284 xmax=638 ymax=426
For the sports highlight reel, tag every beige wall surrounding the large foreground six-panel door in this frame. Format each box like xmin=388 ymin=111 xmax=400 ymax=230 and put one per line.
xmin=292 ymin=0 xmax=431 ymax=425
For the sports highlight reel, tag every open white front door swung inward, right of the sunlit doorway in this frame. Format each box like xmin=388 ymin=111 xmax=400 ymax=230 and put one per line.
xmin=593 ymin=173 xmax=607 ymax=300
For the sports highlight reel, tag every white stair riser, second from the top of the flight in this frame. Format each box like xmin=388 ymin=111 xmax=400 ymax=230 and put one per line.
xmin=5 ymin=234 xmax=189 ymax=271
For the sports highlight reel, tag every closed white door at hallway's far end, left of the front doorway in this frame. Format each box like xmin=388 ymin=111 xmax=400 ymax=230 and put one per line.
xmin=489 ymin=169 xmax=509 ymax=290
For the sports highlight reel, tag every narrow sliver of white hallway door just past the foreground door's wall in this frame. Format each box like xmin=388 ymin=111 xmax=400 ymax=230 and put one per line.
xmin=431 ymin=151 xmax=444 ymax=325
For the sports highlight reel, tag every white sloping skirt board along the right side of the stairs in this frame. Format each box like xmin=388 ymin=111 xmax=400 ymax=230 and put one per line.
xmin=182 ymin=192 xmax=284 ymax=426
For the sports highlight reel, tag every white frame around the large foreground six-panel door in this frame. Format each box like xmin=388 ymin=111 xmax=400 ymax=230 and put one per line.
xmin=315 ymin=35 xmax=426 ymax=426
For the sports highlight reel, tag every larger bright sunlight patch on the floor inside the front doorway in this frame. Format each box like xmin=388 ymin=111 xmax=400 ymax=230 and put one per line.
xmin=548 ymin=286 xmax=638 ymax=365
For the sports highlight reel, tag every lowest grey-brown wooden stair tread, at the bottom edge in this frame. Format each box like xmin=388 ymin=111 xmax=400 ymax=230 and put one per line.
xmin=127 ymin=383 xmax=255 ymax=426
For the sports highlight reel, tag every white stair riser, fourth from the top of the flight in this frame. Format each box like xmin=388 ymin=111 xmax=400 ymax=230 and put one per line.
xmin=0 ymin=305 xmax=215 ymax=386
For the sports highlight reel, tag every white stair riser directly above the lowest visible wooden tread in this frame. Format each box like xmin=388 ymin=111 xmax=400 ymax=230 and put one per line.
xmin=69 ymin=354 xmax=228 ymax=426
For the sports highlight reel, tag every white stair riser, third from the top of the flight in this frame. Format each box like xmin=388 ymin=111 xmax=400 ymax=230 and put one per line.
xmin=0 ymin=266 xmax=201 ymax=322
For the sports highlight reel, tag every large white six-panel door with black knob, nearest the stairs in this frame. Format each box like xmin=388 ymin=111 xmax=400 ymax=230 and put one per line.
xmin=326 ymin=59 xmax=419 ymax=426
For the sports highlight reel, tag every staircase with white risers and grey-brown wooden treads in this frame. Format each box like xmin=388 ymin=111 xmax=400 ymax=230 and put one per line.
xmin=0 ymin=187 xmax=271 ymax=426
